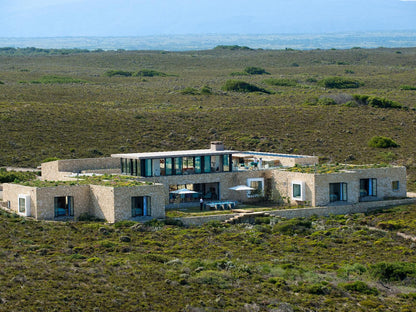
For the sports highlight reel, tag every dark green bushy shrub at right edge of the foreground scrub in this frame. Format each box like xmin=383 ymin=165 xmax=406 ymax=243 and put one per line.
xmin=369 ymin=262 xmax=416 ymax=281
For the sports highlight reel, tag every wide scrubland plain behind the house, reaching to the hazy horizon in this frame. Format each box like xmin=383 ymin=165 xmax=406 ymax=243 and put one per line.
xmin=0 ymin=46 xmax=416 ymax=189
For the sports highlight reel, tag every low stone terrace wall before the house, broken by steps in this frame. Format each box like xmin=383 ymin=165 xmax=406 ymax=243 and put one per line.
xmin=175 ymin=198 xmax=416 ymax=226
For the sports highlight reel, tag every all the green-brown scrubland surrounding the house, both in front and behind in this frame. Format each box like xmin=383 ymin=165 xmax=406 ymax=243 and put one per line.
xmin=0 ymin=46 xmax=416 ymax=311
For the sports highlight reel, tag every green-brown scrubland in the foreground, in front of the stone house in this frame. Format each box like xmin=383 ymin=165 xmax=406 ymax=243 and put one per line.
xmin=0 ymin=206 xmax=416 ymax=311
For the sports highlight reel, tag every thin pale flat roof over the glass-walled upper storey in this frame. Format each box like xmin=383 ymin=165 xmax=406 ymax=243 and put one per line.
xmin=111 ymin=149 xmax=240 ymax=159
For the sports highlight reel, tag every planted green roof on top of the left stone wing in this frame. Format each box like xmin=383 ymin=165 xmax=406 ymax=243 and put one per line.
xmin=15 ymin=175 xmax=154 ymax=187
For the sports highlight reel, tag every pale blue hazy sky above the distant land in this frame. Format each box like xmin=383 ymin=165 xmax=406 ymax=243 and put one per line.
xmin=0 ymin=0 xmax=416 ymax=37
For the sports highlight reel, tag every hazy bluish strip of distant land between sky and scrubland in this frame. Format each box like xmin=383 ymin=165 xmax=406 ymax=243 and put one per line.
xmin=0 ymin=31 xmax=416 ymax=51
